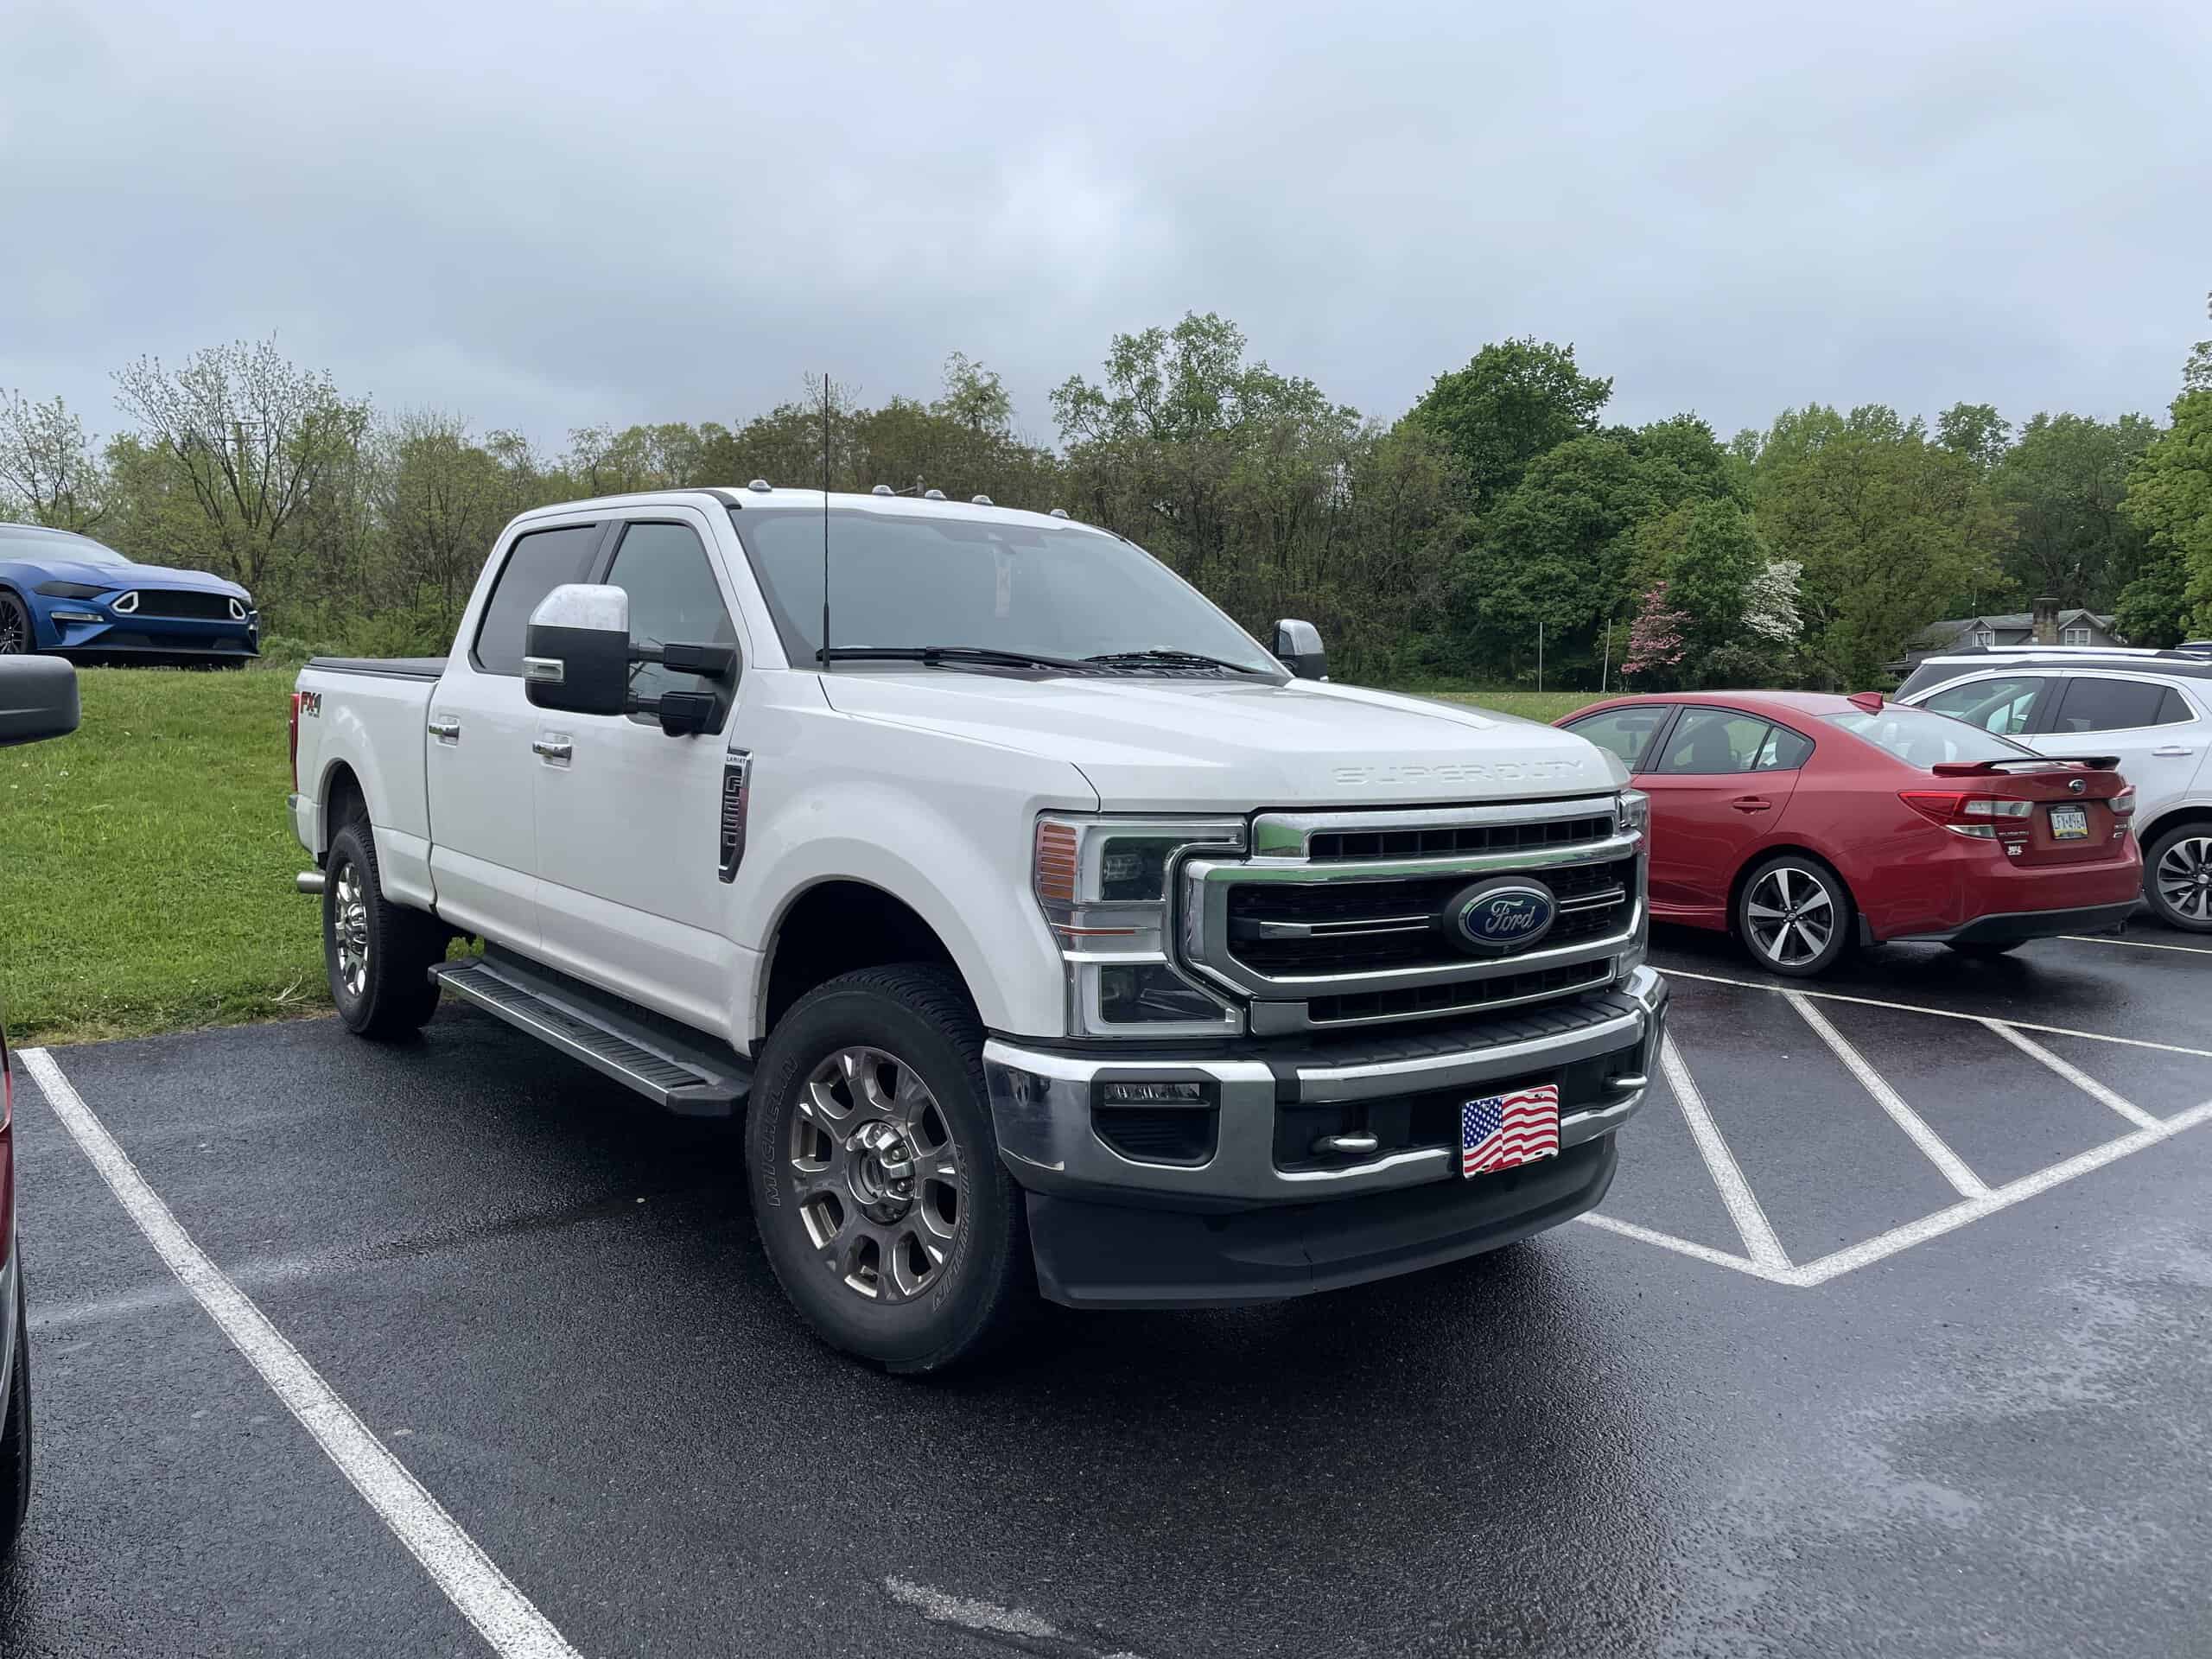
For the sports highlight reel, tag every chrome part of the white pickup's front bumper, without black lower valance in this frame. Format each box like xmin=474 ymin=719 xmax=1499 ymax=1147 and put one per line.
xmin=982 ymin=969 xmax=1668 ymax=1204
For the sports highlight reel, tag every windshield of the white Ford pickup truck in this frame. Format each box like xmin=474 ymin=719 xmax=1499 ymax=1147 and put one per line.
xmin=730 ymin=506 xmax=1283 ymax=677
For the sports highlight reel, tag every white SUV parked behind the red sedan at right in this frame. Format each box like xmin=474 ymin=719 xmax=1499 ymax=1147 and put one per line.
xmin=1896 ymin=646 xmax=2212 ymax=933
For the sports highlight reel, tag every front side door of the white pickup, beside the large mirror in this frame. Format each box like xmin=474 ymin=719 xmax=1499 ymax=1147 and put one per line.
xmin=536 ymin=506 xmax=743 ymax=1028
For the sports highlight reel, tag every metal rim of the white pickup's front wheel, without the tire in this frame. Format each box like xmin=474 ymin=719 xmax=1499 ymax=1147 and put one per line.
xmin=785 ymin=1048 xmax=964 ymax=1303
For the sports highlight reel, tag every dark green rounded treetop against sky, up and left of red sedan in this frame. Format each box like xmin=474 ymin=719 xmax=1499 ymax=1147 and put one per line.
xmin=1407 ymin=336 xmax=1612 ymax=511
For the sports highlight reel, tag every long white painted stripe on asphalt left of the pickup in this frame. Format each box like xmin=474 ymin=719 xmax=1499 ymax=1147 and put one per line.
xmin=17 ymin=1048 xmax=577 ymax=1659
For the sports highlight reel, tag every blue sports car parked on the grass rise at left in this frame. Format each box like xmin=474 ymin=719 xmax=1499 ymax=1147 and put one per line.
xmin=0 ymin=524 xmax=261 ymax=668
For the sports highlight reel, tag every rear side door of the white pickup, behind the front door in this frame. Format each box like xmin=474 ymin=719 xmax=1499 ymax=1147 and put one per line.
xmin=425 ymin=520 xmax=608 ymax=951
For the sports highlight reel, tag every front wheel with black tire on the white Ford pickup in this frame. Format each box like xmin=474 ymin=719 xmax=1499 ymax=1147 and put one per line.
xmin=746 ymin=964 xmax=1031 ymax=1371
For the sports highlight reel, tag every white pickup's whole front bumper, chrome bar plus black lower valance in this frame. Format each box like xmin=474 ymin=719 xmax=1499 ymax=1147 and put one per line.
xmin=984 ymin=969 xmax=1668 ymax=1305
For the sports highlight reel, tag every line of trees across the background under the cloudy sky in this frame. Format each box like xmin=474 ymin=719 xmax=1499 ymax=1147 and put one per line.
xmin=0 ymin=298 xmax=2212 ymax=688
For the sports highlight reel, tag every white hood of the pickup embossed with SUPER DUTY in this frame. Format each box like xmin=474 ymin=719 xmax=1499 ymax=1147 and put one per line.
xmin=823 ymin=668 xmax=1628 ymax=812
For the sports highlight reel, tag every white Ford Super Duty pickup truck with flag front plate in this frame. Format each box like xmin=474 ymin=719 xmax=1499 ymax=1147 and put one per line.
xmin=289 ymin=482 xmax=1666 ymax=1371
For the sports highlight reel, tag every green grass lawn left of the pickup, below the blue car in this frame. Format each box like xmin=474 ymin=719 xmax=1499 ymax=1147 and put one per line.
xmin=0 ymin=668 xmax=327 ymax=1042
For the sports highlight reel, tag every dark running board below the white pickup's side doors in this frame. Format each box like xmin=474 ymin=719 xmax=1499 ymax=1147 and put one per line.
xmin=429 ymin=951 xmax=752 ymax=1117
